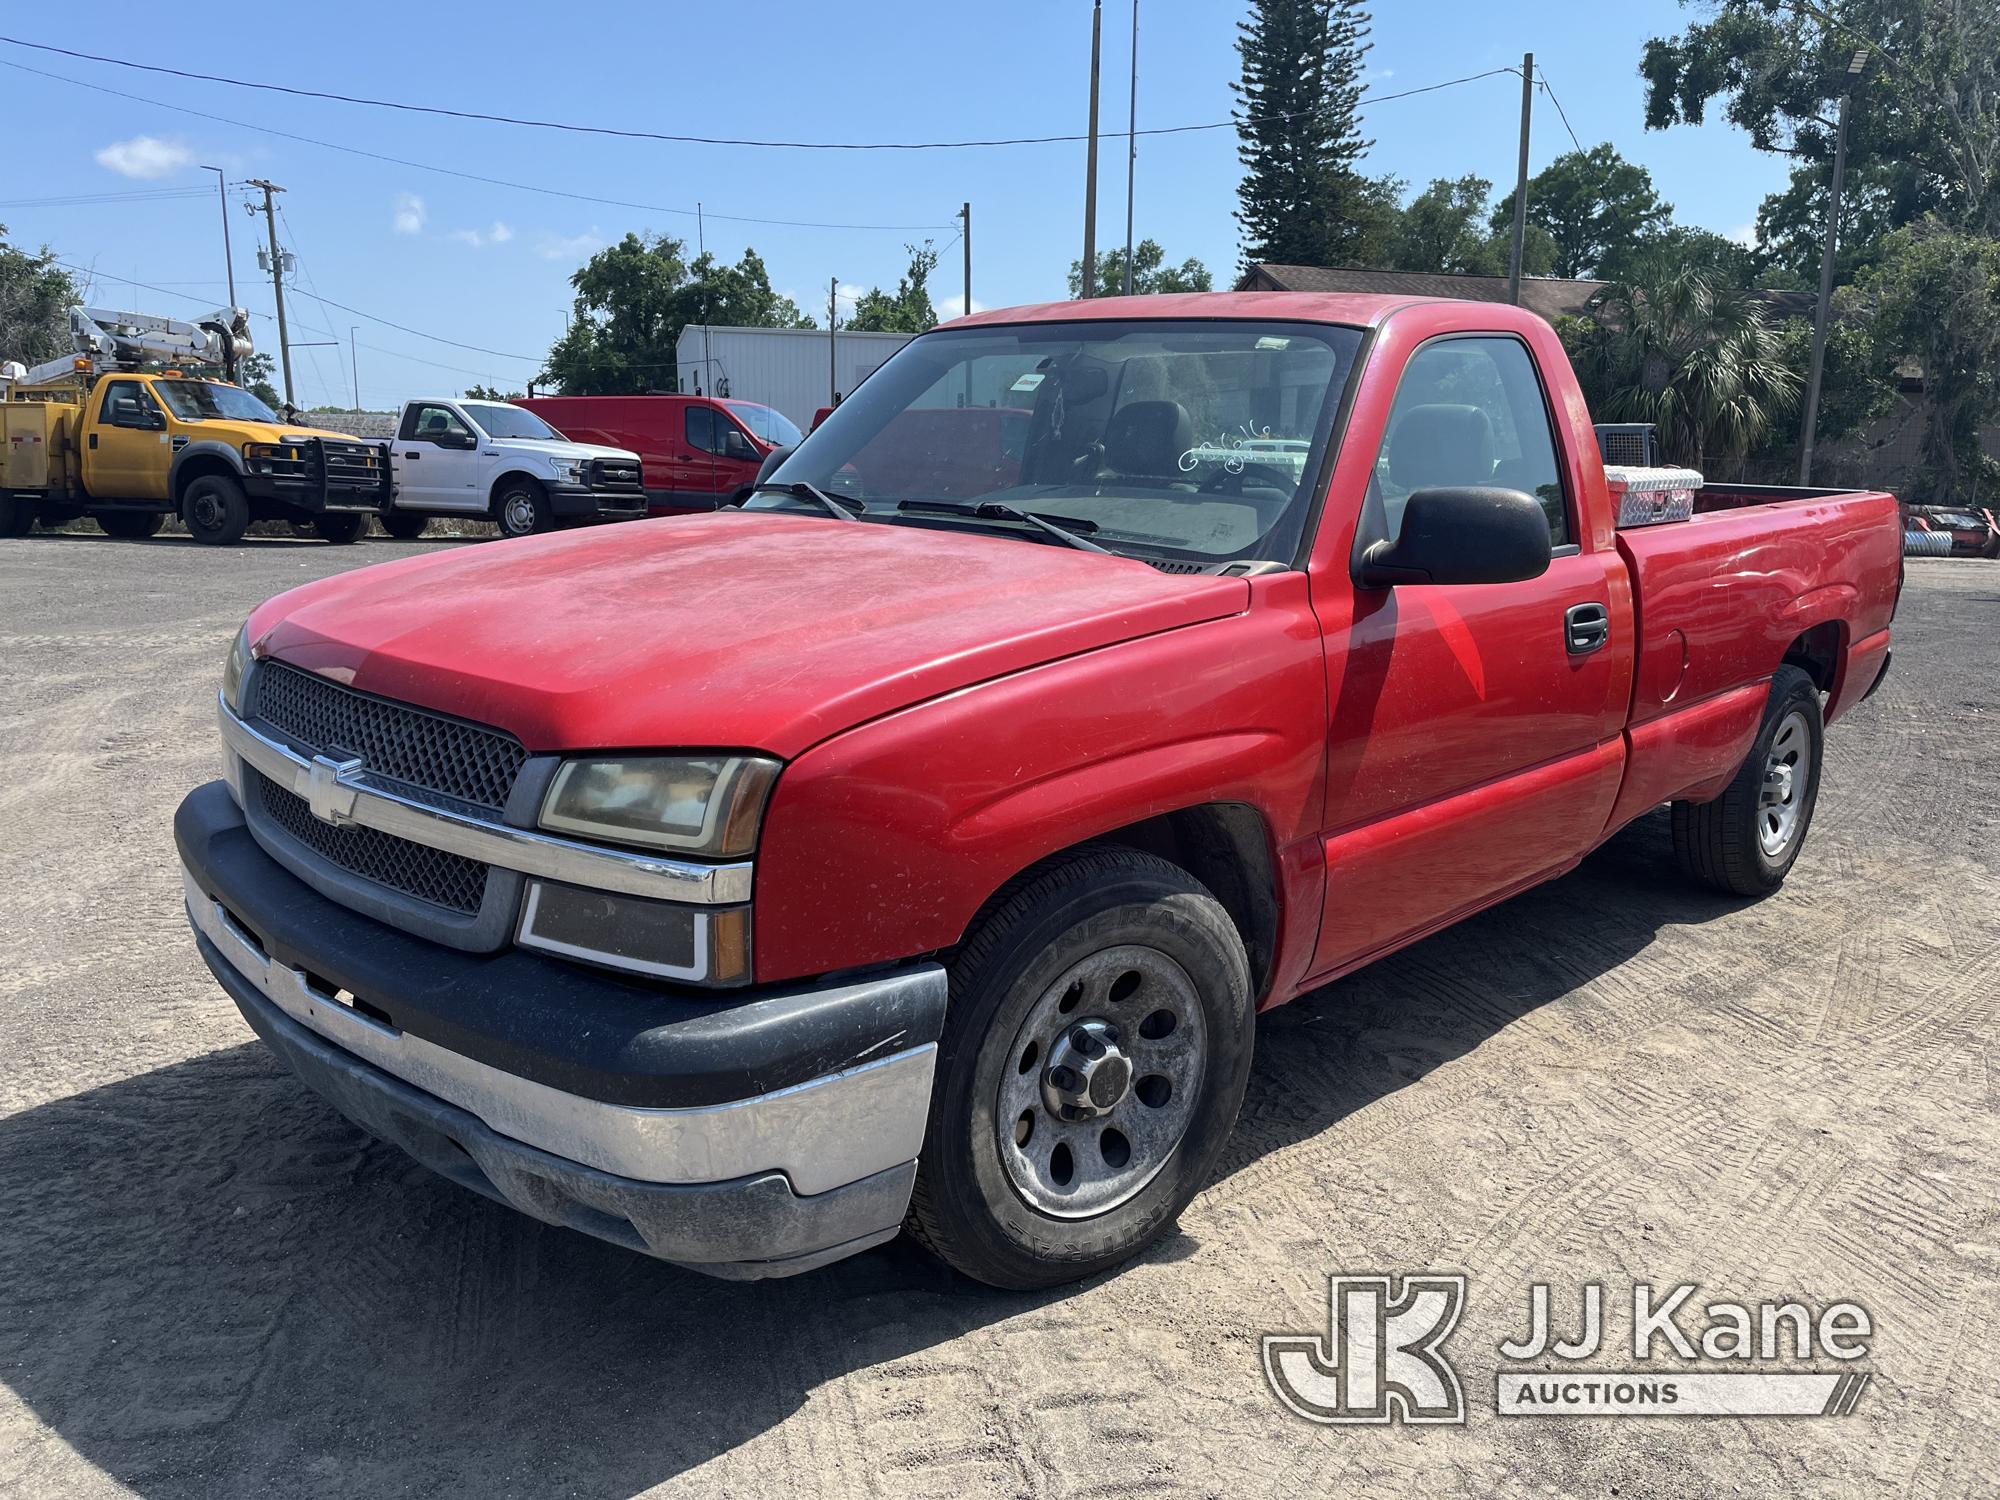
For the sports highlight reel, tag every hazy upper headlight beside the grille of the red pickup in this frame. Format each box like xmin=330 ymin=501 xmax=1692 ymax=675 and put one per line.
xmin=542 ymin=756 xmax=778 ymax=856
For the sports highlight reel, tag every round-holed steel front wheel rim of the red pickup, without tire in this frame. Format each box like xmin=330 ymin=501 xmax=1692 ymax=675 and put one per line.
xmin=994 ymin=944 xmax=1208 ymax=1218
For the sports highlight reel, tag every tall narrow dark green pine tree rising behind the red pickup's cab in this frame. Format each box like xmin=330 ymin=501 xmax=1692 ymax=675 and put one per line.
xmin=1232 ymin=0 xmax=1382 ymax=268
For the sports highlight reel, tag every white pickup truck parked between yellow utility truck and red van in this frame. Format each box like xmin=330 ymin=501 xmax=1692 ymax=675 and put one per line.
xmin=382 ymin=396 xmax=646 ymax=540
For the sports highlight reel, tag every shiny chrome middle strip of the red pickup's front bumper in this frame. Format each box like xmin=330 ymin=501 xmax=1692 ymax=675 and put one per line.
xmin=182 ymin=870 xmax=944 ymax=1196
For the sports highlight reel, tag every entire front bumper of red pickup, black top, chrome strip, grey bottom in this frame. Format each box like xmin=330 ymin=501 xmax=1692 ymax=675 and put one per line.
xmin=174 ymin=784 xmax=944 ymax=1278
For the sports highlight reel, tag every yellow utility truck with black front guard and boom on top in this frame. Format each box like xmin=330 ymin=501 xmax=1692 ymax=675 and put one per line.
xmin=0 ymin=308 xmax=392 ymax=546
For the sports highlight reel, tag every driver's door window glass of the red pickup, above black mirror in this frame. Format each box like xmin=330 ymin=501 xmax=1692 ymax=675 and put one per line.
xmin=1374 ymin=338 xmax=1570 ymax=546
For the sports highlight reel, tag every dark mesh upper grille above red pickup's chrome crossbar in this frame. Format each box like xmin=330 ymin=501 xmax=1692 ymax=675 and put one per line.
xmin=252 ymin=662 xmax=528 ymax=816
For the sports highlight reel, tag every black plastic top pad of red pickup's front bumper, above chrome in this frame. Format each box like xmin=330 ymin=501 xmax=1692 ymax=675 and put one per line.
xmin=174 ymin=782 xmax=944 ymax=1108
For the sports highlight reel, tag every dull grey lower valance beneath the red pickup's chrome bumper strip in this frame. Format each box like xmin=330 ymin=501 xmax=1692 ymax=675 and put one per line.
xmin=230 ymin=964 xmax=916 ymax=1280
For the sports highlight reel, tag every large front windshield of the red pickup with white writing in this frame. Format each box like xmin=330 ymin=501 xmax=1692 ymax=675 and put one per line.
xmin=748 ymin=320 xmax=1360 ymax=564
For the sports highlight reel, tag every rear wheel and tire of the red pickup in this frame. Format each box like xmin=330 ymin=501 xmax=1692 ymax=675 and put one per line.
xmin=1672 ymin=666 xmax=1826 ymax=896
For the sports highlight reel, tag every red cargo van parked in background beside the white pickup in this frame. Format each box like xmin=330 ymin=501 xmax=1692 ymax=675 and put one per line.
xmin=516 ymin=396 xmax=802 ymax=516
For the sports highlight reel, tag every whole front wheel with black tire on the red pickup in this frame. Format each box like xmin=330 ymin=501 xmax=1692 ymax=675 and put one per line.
xmin=906 ymin=844 xmax=1256 ymax=1290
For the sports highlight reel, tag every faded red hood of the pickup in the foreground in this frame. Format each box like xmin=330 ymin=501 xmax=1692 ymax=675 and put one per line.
xmin=250 ymin=512 xmax=1250 ymax=758
